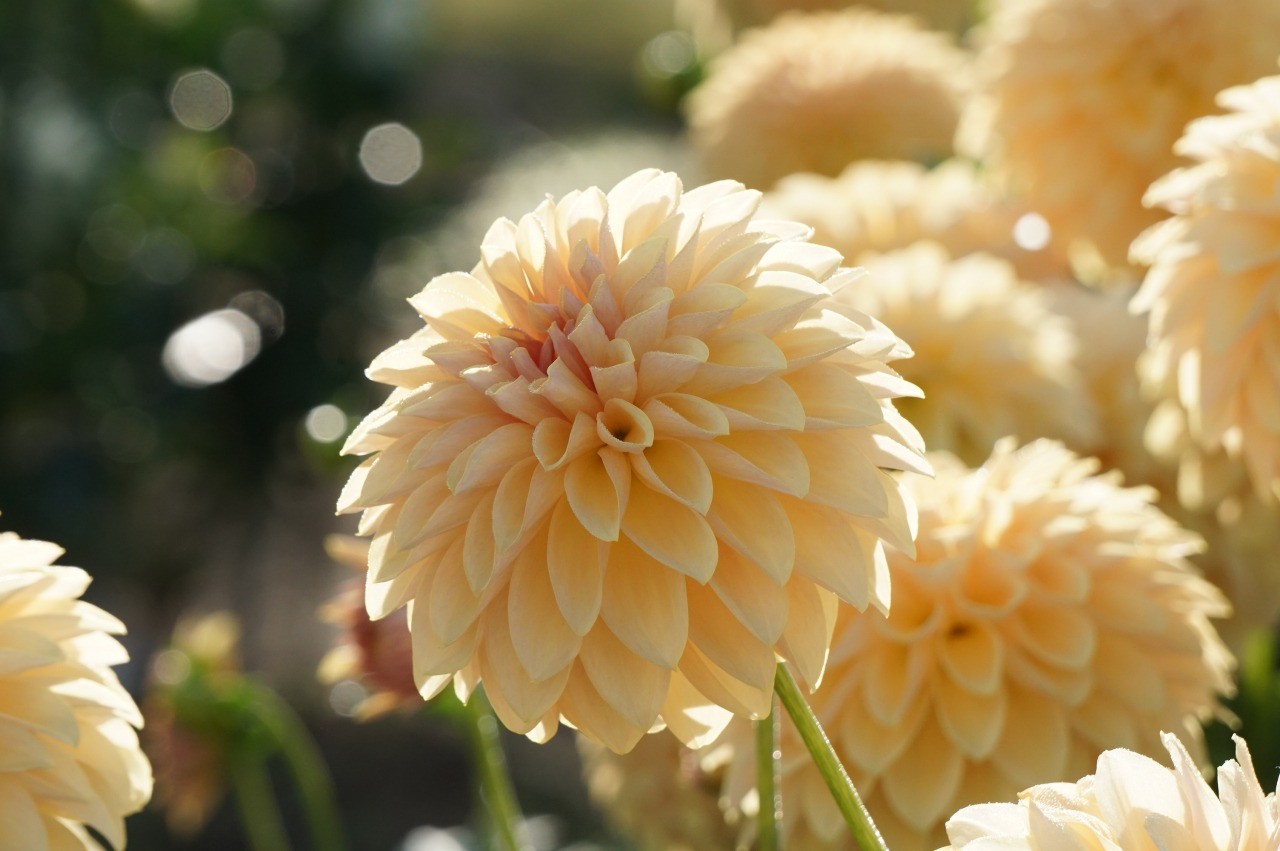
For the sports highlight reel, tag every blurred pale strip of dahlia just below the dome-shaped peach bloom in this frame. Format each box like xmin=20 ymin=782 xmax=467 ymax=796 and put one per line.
xmin=762 ymin=160 xmax=1070 ymax=282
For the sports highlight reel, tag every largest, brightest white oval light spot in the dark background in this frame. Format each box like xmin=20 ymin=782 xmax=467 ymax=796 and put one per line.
xmin=160 ymin=308 xmax=261 ymax=386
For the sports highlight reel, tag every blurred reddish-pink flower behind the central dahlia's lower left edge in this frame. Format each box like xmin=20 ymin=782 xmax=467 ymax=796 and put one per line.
xmin=317 ymin=535 xmax=422 ymax=720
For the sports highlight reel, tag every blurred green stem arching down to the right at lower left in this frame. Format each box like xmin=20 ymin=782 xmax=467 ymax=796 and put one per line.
xmin=253 ymin=683 xmax=347 ymax=851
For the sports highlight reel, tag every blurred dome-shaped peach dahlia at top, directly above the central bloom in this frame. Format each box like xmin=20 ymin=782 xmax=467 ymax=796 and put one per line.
xmin=686 ymin=9 xmax=969 ymax=188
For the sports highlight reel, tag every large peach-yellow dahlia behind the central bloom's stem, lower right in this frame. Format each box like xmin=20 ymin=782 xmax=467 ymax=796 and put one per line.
xmin=731 ymin=440 xmax=1231 ymax=851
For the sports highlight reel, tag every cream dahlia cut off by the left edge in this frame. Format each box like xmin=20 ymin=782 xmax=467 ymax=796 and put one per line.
xmin=0 ymin=532 xmax=151 ymax=848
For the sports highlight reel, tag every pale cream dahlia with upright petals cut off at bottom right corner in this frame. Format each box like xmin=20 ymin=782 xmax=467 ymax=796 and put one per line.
xmin=947 ymin=733 xmax=1280 ymax=851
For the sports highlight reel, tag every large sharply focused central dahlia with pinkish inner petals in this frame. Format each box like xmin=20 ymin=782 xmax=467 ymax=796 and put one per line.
xmin=339 ymin=170 xmax=928 ymax=751
